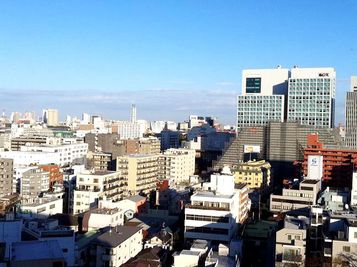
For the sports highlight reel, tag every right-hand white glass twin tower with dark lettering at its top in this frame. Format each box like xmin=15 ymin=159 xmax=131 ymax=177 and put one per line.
xmin=287 ymin=67 xmax=336 ymax=128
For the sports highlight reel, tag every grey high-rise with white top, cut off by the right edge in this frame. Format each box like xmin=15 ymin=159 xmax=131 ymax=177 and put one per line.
xmin=345 ymin=76 xmax=357 ymax=149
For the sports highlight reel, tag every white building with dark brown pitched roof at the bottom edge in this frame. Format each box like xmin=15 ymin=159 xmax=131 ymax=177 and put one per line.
xmin=91 ymin=226 xmax=143 ymax=266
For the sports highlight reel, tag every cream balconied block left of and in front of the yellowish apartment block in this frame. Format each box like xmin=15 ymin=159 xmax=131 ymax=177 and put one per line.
xmin=72 ymin=171 xmax=127 ymax=214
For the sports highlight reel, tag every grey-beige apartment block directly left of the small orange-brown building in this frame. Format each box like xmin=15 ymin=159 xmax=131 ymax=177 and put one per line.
xmin=20 ymin=167 xmax=50 ymax=203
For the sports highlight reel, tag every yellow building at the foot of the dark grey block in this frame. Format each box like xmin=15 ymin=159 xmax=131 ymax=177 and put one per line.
xmin=233 ymin=160 xmax=271 ymax=190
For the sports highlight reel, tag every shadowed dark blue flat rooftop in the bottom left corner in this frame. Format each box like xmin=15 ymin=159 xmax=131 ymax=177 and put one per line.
xmin=11 ymin=240 xmax=64 ymax=261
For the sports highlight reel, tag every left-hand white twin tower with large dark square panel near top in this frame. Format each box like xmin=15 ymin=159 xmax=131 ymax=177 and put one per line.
xmin=237 ymin=66 xmax=290 ymax=129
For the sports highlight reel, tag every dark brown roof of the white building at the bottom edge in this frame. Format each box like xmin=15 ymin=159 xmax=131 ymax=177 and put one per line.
xmin=94 ymin=226 xmax=141 ymax=247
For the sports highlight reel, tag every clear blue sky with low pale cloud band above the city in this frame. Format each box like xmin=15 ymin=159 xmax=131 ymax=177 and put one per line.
xmin=0 ymin=0 xmax=357 ymax=123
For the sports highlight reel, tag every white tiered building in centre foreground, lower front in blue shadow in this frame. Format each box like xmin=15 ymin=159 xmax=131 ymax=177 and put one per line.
xmin=184 ymin=168 xmax=248 ymax=243
